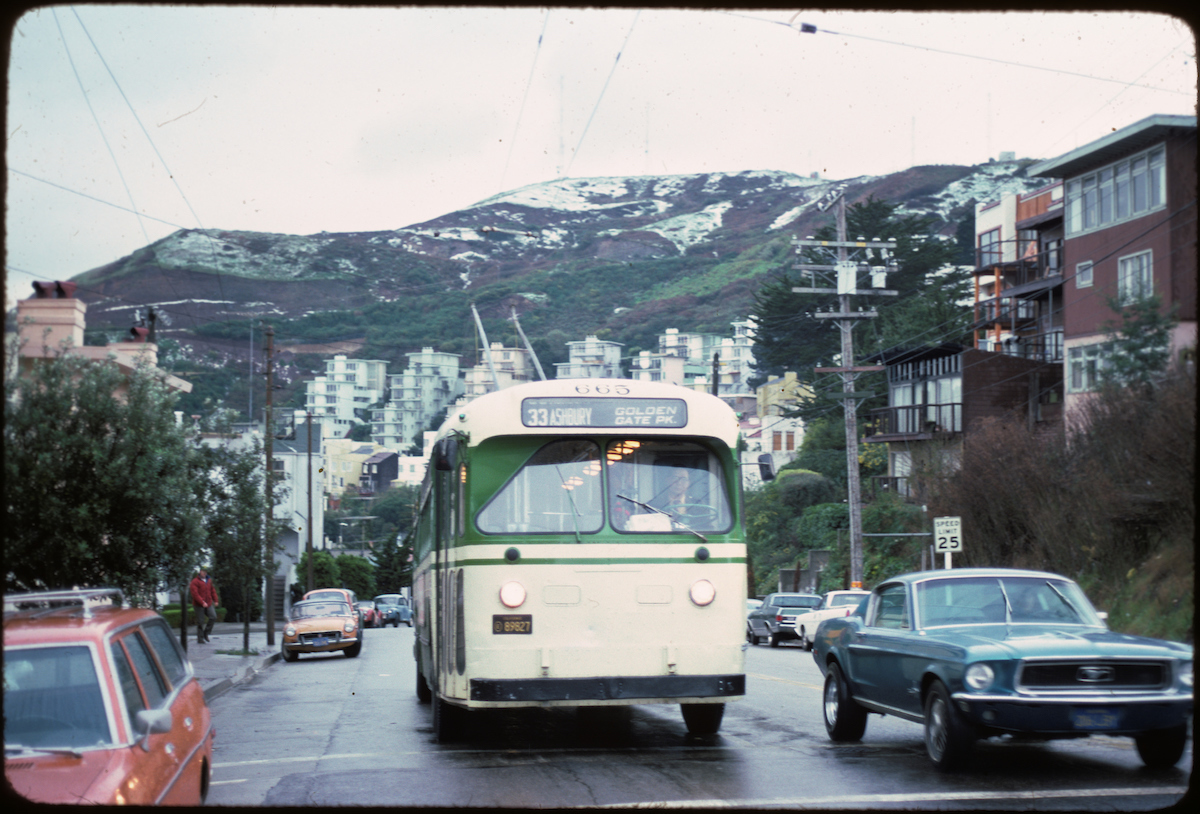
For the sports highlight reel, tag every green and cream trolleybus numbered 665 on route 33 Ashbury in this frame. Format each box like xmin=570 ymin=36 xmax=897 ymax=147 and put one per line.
xmin=412 ymin=379 xmax=746 ymax=740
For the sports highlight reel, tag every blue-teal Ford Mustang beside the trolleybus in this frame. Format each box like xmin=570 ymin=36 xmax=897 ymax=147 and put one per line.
xmin=812 ymin=568 xmax=1193 ymax=770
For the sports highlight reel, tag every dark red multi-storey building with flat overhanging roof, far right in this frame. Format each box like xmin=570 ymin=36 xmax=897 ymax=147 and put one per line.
xmin=1028 ymin=114 xmax=1196 ymax=414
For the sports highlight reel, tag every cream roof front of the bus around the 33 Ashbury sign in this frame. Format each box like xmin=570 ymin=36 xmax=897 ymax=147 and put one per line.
xmin=437 ymin=378 xmax=738 ymax=448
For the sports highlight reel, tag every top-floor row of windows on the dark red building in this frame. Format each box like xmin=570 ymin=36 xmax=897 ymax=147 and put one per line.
xmin=1066 ymin=146 xmax=1166 ymax=234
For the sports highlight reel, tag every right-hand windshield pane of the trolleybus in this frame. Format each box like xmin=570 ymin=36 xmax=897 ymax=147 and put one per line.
xmin=605 ymin=439 xmax=732 ymax=533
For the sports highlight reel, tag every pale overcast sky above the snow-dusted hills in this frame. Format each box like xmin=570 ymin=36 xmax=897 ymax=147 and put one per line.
xmin=5 ymin=5 xmax=1196 ymax=307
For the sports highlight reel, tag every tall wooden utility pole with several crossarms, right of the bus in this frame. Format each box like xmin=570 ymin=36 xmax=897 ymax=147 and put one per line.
xmin=792 ymin=187 xmax=896 ymax=588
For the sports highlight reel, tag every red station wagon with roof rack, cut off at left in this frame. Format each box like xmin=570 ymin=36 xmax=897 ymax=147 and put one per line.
xmin=4 ymin=588 xmax=216 ymax=806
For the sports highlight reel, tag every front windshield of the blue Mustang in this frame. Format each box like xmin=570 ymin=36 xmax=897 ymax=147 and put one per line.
xmin=917 ymin=576 xmax=1102 ymax=628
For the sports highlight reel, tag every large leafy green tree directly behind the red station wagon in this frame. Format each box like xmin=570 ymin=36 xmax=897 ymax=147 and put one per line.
xmin=4 ymin=353 xmax=205 ymax=605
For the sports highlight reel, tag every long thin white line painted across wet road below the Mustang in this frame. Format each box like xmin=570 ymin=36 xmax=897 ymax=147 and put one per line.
xmin=585 ymin=785 xmax=1188 ymax=809
